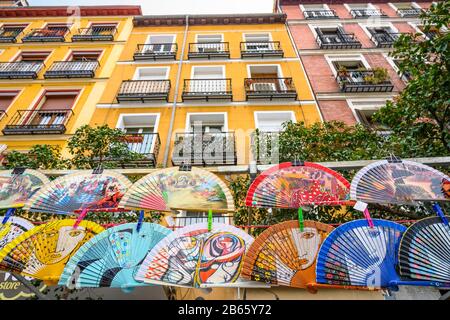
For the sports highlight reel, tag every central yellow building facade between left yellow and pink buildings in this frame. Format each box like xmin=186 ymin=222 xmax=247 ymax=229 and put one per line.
xmin=91 ymin=14 xmax=321 ymax=167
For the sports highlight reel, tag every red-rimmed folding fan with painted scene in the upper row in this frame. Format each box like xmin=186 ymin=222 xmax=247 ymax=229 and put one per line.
xmin=246 ymin=162 xmax=351 ymax=209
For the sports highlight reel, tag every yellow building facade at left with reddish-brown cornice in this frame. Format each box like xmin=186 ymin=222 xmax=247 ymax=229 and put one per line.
xmin=0 ymin=6 xmax=141 ymax=158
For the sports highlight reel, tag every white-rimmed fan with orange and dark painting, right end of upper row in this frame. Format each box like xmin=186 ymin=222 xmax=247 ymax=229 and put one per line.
xmin=350 ymin=159 xmax=450 ymax=204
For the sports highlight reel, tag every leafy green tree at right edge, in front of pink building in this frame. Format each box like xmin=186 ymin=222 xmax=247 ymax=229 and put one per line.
xmin=374 ymin=1 xmax=450 ymax=156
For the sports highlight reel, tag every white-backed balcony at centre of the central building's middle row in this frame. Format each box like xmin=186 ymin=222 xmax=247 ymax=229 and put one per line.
xmin=182 ymin=79 xmax=233 ymax=101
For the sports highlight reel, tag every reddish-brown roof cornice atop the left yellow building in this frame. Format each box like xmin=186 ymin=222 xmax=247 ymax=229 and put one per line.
xmin=0 ymin=6 xmax=142 ymax=18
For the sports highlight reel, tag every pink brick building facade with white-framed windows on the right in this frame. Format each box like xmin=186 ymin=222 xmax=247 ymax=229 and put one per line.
xmin=278 ymin=0 xmax=433 ymax=129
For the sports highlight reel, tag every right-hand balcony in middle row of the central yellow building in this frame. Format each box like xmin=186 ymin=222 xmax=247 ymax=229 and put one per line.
xmin=244 ymin=78 xmax=297 ymax=101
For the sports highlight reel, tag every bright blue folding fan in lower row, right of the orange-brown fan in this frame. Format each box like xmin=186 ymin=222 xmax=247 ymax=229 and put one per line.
xmin=316 ymin=219 xmax=406 ymax=289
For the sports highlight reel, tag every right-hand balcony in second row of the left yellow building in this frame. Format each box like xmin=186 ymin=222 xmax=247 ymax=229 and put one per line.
xmin=44 ymin=61 xmax=100 ymax=79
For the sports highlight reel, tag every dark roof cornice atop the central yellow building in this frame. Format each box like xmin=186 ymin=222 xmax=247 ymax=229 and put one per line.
xmin=134 ymin=13 xmax=286 ymax=27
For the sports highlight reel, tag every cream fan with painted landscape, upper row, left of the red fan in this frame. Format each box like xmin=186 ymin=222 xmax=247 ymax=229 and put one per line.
xmin=119 ymin=167 xmax=234 ymax=212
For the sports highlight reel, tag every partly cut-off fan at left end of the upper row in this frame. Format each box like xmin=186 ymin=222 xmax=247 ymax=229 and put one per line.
xmin=0 ymin=168 xmax=50 ymax=209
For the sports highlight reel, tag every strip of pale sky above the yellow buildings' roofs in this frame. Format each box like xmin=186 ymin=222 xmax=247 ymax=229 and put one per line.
xmin=28 ymin=0 xmax=274 ymax=15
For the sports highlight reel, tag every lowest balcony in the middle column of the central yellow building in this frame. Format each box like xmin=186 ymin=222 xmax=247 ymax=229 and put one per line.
xmin=172 ymin=132 xmax=237 ymax=166
